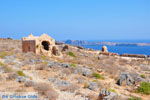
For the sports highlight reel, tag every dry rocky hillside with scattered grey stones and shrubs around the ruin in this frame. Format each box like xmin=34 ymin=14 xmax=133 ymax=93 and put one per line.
xmin=0 ymin=40 xmax=150 ymax=100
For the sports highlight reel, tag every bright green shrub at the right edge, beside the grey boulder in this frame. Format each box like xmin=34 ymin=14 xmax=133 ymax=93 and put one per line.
xmin=137 ymin=82 xmax=150 ymax=95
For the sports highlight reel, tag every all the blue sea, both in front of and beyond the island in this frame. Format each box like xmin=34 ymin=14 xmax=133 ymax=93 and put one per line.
xmin=83 ymin=40 xmax=150 ymax=55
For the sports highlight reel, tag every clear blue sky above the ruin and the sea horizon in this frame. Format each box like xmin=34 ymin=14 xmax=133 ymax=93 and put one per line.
xmin=0 ymin=0 xmax=150 ymax=40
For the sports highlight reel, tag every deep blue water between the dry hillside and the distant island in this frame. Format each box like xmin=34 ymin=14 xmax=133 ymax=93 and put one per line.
xmin=83 ymin=45 xmax=150 ymax=55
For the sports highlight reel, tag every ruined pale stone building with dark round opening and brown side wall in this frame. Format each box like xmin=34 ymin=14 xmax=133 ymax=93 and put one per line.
xmin=22 ymin=34 xmax=62 ymax=56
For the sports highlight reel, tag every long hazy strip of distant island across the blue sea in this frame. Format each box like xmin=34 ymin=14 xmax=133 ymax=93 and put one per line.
xmin=61 ymin=40 xmax=150 ymax=46
